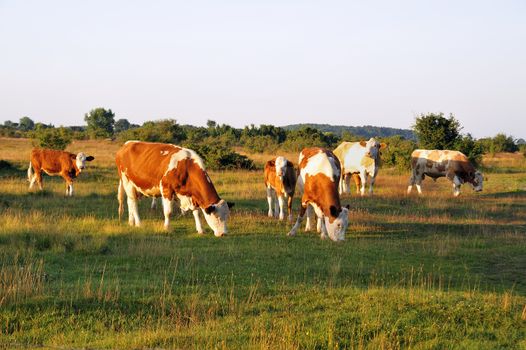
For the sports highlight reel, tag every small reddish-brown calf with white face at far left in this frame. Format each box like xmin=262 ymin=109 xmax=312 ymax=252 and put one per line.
xmin=27 ymin=148 xmax=95 ymax=196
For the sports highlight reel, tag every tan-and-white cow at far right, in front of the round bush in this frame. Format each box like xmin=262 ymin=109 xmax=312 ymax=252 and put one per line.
xmin=407 ymin=149 xmax=484 ymax=197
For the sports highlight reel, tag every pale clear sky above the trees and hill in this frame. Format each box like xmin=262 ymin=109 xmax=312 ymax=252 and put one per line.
xmin=0 ymin=0 xmax=526 ymax=138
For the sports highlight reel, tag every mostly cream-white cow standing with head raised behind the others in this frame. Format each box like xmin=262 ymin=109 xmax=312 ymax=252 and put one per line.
xmin=334 ymin=137 xmax=386 ymax=196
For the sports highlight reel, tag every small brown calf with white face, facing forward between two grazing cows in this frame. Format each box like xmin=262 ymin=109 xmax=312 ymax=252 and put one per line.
xmin=265 ymin=156 xmax=296 ymax=222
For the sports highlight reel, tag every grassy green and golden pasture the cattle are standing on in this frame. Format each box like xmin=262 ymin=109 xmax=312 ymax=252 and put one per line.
xmin=0 ymin=139 xmax=526 ymax=349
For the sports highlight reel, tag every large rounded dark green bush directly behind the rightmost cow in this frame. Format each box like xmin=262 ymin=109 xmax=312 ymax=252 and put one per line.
xmin=413 ymin=113 xmax=462 ymax=149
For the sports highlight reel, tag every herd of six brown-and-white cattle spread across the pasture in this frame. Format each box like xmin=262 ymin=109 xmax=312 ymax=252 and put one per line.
xmin=27 ymin=138 xmax=483 ymax=241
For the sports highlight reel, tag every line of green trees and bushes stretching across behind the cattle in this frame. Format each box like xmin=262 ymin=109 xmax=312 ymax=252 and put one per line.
xmin=0 ymin=108 xmax=526 ymax=169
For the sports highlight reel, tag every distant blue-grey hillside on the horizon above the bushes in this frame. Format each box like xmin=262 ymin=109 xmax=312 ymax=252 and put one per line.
xmin=282 ymin=124 xmax=416 ymax=140
